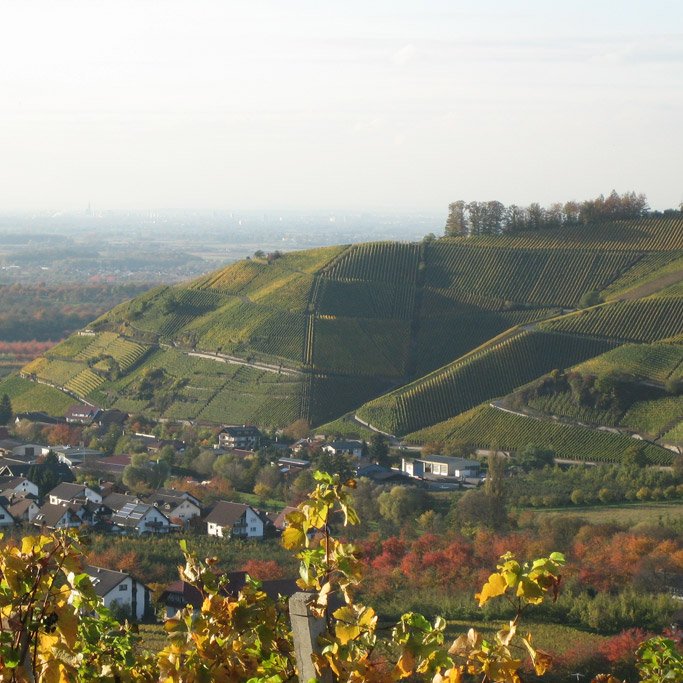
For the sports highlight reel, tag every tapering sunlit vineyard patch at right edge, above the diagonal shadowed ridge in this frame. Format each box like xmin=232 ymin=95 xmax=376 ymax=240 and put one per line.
xmin=541 ymin=297 xmax=683 ymax=342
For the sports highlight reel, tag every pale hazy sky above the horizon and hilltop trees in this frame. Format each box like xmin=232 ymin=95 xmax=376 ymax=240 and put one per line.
xmin=0 ymin=0 xmax=683 ymax=213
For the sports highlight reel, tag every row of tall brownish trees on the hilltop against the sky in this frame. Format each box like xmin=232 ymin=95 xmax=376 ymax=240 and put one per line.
xmin=446 ymin=190 xmax=649 ymax=237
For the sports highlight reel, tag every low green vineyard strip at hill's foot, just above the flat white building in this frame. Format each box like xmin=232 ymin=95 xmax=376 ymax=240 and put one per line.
xmin=407 ymin=406 xmax=673 ymax=465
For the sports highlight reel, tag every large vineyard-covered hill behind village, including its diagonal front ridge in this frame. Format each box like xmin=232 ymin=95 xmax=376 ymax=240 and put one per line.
xmin=0 ymin=218 xmax=683 ymax=434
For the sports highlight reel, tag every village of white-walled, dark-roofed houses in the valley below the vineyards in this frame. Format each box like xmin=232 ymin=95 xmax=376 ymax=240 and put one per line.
xmin=0 ymin=404 xmax=482 ymax=621
